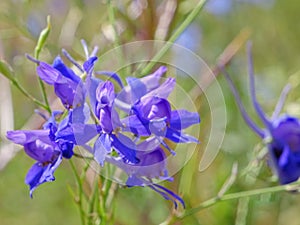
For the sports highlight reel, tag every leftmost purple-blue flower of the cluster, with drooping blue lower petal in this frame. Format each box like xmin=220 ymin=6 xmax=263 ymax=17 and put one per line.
xmin=7 ymin=112 xmax=83 ymax=197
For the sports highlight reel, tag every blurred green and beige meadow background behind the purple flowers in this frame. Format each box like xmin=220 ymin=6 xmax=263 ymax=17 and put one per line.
xmin=0 ymin=0 xmax=300 ymax=225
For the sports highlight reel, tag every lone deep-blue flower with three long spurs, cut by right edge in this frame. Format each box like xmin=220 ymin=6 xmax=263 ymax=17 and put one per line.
xmin=223 ymin=44 xmax=300 ymax=184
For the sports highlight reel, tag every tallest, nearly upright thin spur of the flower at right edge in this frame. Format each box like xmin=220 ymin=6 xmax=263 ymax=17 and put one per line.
xmin=247 ymin=42 xmax=272 ymax=129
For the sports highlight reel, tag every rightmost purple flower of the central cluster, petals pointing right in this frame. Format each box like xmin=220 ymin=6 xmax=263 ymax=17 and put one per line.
xmin=118 ymin=67 xmax=200 ymax=147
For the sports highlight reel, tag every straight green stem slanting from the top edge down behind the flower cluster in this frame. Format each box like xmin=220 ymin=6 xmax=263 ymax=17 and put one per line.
xmin=137 ymin=0 xmax=207 ymax=75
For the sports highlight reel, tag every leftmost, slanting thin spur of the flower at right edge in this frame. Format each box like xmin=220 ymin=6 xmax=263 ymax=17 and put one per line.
xmin=220 ymin=67 xmax=265 ymax=138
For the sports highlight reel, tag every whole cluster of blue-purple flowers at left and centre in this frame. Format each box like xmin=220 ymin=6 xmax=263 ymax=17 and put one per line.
xmin=7 ymin=43 xmax=200 ymax=206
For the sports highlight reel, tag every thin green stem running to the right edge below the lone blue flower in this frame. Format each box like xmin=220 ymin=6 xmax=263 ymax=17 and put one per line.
xmin=180 ymin=182 xmax=300 ymax=218
